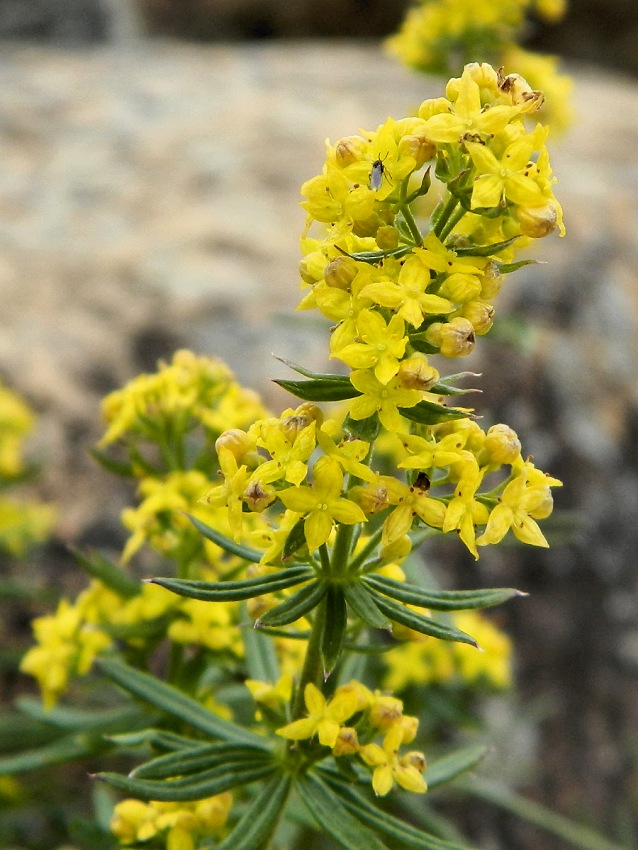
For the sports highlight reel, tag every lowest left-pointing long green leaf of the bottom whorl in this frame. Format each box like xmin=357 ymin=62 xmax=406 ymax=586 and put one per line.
xmin=93 ymin=762 xmax=275 ymax=803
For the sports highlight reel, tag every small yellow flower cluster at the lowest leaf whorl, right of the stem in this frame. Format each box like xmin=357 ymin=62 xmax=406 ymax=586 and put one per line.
xmin=277 ymin=680 xmax=427 ymax=796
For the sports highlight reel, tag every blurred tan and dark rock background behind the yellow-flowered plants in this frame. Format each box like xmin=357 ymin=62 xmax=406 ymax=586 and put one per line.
xmin=0 ymin=0 xmax=638 ymax=850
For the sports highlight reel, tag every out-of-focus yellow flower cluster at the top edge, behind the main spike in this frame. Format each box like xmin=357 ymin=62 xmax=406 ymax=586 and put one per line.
xmin=387 ymin=0 xmax=571 ymax=127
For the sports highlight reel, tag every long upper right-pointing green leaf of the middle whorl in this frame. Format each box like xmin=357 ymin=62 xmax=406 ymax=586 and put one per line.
xmin=362 ymin=575 xmax=526 ymax=611
